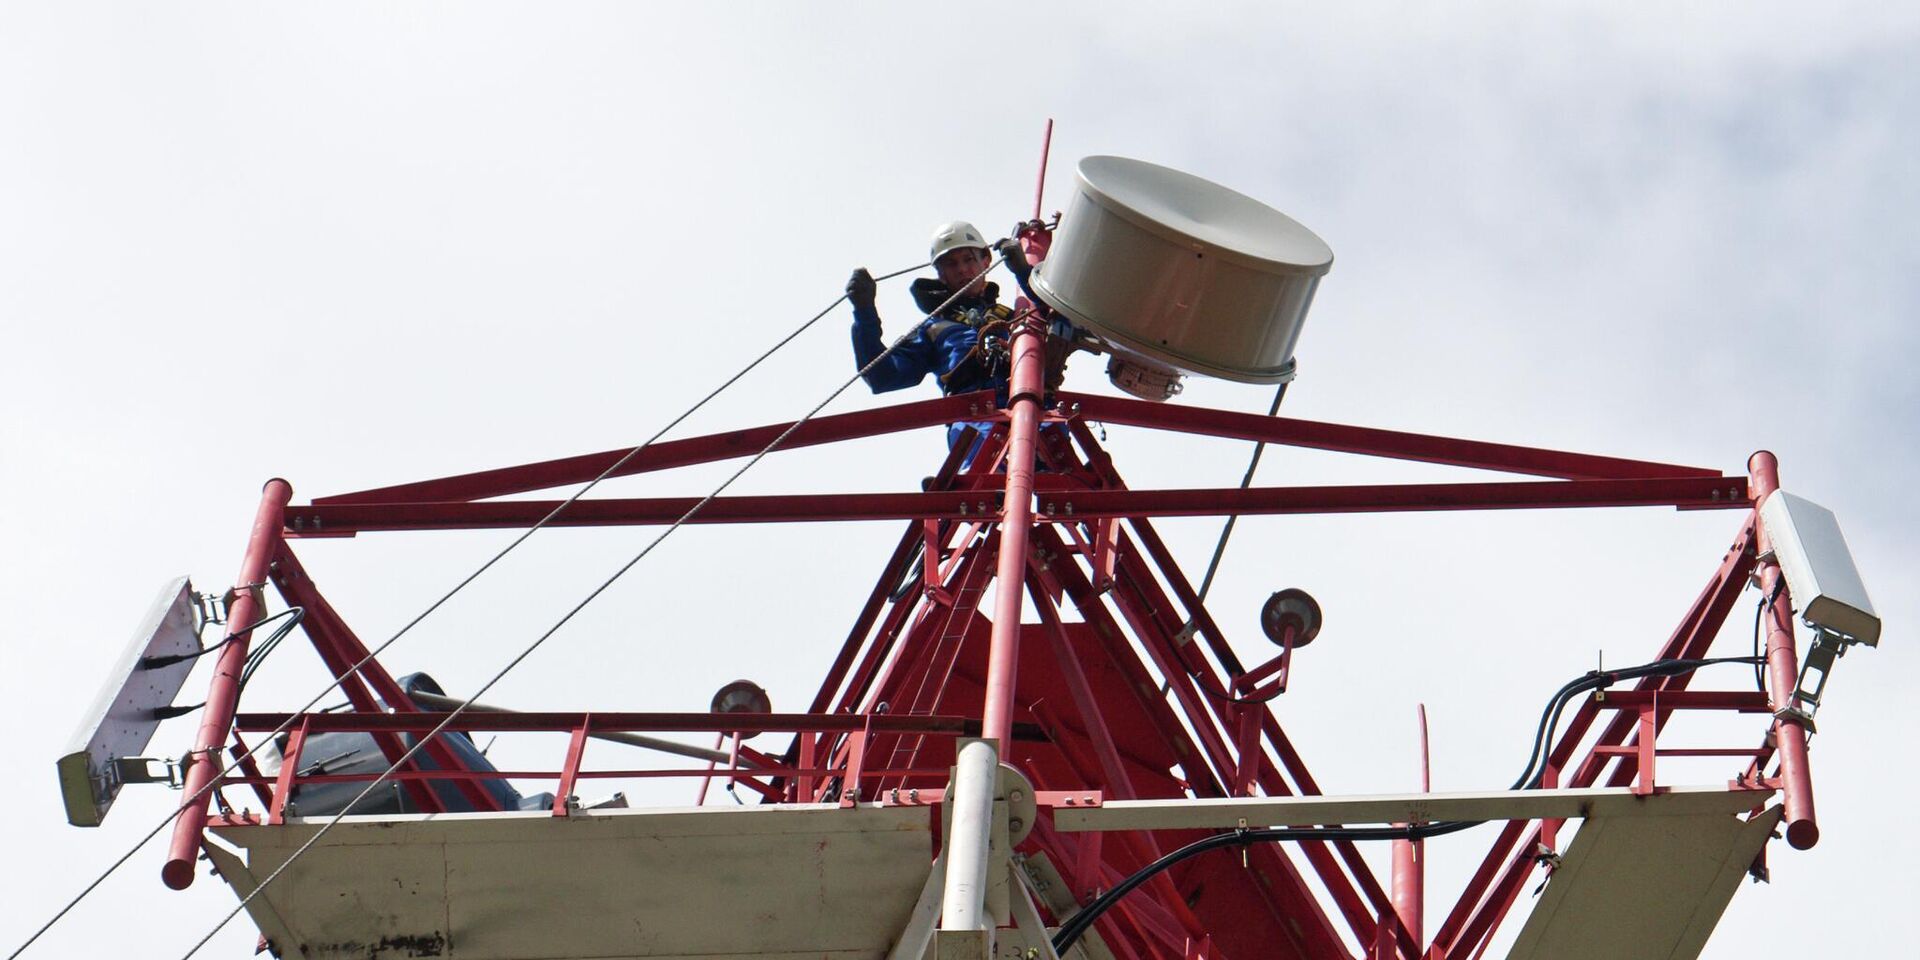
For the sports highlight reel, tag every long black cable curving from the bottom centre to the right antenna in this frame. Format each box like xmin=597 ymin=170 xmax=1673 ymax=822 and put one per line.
xmin=1054 ymin=657 xmax=1753 ymax=956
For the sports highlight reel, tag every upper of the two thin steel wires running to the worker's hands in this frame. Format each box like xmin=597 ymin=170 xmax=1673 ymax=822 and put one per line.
xmin=6 ymin=263 xmax=929 ymax=960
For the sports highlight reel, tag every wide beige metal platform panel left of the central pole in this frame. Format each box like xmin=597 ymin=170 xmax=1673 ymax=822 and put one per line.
xmin=217 ymin=804 xmax=933 ymax=960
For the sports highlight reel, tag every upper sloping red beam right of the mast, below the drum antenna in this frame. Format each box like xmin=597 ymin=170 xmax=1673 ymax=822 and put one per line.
xmin=1058 ymin=392 xmax=1720 ymax=480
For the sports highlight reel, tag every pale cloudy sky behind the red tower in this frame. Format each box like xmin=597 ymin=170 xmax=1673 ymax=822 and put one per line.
xmin=0 ymin=2 xmax=1920 ymax=958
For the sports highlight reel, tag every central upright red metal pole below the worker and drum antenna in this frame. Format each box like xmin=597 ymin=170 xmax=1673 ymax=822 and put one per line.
xmin=979 ymin=317 xmax=1046 ymax=749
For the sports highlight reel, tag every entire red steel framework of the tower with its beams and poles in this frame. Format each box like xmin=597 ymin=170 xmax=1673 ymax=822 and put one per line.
xmin=165 ymin=324 xmax=1818 ymax=960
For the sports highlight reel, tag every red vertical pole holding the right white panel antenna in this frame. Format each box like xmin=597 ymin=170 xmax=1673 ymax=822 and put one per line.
xmin=1747 ymin=449 xmax=1820 ymax=851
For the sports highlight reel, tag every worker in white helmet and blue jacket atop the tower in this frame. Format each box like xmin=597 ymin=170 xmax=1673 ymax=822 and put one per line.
xmin=847 ymin=221 xmax=1071 ymax=459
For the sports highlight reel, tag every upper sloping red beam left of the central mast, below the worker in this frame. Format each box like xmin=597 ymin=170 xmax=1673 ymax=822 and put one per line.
xmin=313 ymin=392 xmax=1002 ymax=503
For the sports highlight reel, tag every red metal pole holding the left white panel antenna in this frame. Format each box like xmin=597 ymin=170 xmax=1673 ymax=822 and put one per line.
xmin=159 ymin=478 xmax=294 ymax=891
